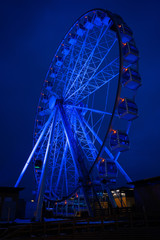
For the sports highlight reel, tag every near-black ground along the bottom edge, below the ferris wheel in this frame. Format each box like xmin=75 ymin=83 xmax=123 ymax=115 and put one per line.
xmin=0 ymin=209 xmax=160 ymax=240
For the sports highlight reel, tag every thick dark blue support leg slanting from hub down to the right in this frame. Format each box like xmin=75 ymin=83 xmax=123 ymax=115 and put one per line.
xmin=58 ymin=102 xmax=93 ymax=216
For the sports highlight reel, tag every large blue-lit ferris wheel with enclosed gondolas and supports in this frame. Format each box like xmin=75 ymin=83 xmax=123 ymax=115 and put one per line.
xmin=15 ymin=9 xmax=141 ymax=219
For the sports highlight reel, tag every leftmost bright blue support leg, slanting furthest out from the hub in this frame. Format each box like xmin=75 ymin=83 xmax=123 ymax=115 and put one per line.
xmin=14 ymin=109 xmax=54 ymax=187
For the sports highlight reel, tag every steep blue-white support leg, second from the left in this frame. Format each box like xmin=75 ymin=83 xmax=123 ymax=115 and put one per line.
xmin=35 ymin=120 xmax=53 ymax=221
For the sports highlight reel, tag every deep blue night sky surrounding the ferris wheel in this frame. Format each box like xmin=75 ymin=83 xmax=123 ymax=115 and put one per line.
xmin=0 ymin=0 xmax=160 ymax=199
